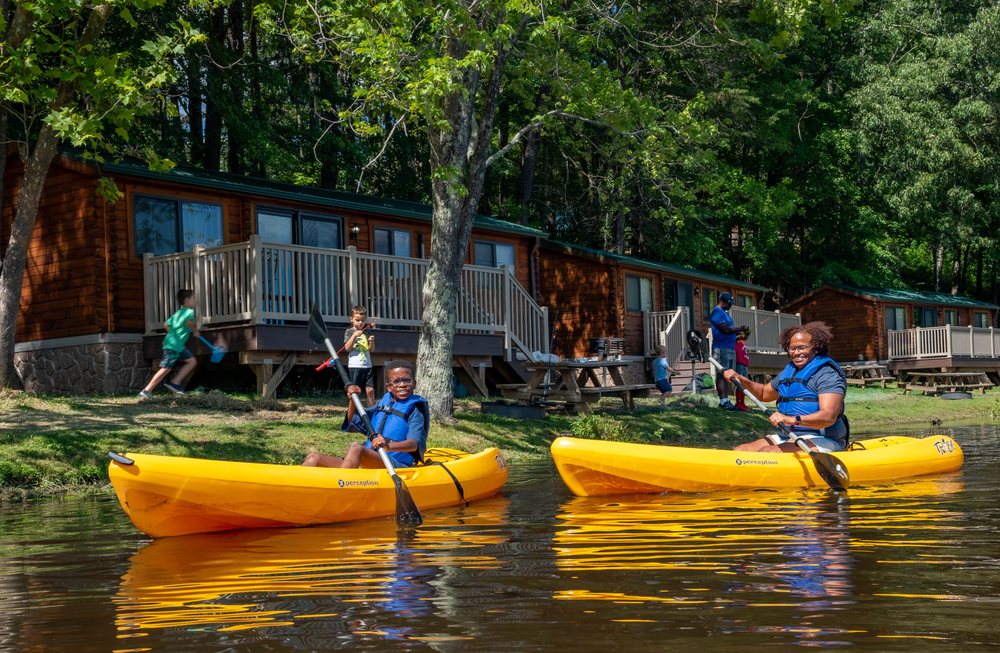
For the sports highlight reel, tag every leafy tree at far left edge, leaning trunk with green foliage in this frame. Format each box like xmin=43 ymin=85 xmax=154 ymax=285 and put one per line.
xmin=0 ymin=0 xmax=199 ymax=387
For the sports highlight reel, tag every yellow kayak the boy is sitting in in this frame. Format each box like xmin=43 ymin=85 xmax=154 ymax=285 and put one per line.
xmin=108 ymin=448 xmax=507 ymax=537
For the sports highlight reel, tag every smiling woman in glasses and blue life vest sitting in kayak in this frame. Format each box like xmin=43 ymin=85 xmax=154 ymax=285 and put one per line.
xmin=725 ymin=322 xmax=848 ymax=452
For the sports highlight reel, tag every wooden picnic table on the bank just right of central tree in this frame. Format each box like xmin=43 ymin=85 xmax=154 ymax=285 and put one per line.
xmin=497 ymin=360 xmax=655 ymax=413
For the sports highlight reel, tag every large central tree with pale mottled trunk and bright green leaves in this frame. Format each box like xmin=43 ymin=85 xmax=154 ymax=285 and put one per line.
xmin=272 ymin=0 xmax=660 ymax=419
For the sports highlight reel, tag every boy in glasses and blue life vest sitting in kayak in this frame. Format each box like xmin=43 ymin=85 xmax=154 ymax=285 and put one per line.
xmin=302 ymin=361 xmax=430 ymax=469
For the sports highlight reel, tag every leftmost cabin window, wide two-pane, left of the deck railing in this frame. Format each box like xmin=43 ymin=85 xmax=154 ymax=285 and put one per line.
xmin=132 ymin=195 xmax=222 ymax=256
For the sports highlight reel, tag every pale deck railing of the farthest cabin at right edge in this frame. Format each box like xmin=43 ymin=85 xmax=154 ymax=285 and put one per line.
xmin=887 ymin=324 xmax=1000 ymax=360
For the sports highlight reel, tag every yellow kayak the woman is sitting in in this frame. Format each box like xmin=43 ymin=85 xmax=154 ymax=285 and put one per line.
xmin=552 ymin=435 xmax=963 ymax=497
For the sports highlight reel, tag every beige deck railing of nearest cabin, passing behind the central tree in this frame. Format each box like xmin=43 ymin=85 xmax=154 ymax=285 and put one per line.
xmin=143 ymin=236 xmax=548 ymax=356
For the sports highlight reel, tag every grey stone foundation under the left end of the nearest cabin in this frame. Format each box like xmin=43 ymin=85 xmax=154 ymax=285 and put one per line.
xmin=14 ymin=335 xmax=153 ymax=395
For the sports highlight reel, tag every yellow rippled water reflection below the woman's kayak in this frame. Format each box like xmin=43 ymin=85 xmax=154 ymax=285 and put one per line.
xmin=553 ymin=475 xmax=964 ymax=646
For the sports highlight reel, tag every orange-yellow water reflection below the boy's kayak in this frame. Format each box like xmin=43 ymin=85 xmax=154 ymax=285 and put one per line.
xmin=114 ymin=497 xmax=508 ymax=651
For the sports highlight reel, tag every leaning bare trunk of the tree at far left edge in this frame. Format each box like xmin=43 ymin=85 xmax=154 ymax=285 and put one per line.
xmin=0 ymin=4 xmax=111 ymax=388
